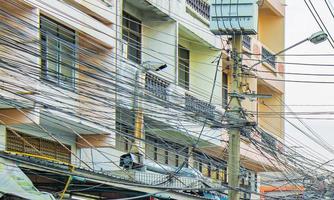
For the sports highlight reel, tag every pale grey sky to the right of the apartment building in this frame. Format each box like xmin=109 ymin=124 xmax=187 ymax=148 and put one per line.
xmin=285 ymin=0 xmax=334 ymax=163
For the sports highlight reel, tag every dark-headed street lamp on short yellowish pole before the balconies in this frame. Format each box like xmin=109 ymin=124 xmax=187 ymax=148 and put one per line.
xmin=120 ymin=61 xmax=167 ymax=168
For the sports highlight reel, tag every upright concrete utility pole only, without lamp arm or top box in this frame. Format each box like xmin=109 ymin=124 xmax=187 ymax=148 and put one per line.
xmin=227 ymin=35 xmax=242 ymax=200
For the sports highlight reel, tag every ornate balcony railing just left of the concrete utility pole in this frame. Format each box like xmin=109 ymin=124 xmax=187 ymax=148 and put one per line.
xmin=185 ymin=94 xmax=215 ymax=120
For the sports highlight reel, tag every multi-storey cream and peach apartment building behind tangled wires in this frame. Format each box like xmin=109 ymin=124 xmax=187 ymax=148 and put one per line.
xmin=0 ymin=0 xmax=284 ymax=199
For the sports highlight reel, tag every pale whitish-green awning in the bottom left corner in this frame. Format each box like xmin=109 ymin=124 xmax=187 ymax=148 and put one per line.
xmin=0 ymin=158 xmax=55 ymax=200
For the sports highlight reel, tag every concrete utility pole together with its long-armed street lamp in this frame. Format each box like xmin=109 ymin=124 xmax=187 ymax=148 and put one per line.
xmin=227 ymin=31 xmax=327 ymax=200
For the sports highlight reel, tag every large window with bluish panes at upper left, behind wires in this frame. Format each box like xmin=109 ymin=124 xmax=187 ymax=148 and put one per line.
xmin=40 ymin=16 xmax=75 ymax=87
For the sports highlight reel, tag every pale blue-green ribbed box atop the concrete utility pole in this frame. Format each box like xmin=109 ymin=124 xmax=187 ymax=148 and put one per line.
xmin=210 ymin=0 xmax=258 ymax=35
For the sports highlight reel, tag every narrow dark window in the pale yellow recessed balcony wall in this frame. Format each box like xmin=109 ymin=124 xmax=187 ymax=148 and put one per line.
xmin=178 ymin=46 xmax=190 ymax=90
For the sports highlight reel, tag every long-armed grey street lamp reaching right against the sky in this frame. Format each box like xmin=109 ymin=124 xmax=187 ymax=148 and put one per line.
xmin=248 ymin=31 xmax=328 ymax=72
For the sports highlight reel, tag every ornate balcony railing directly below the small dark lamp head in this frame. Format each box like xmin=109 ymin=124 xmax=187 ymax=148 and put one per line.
xmin=145 ymin=73 xmax=170 ymax=100
